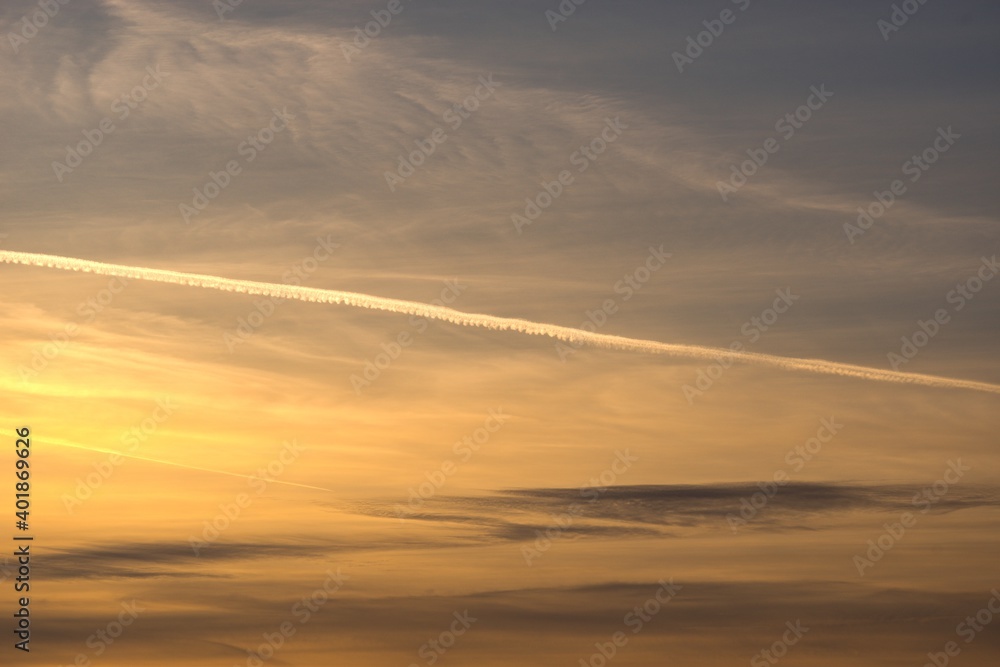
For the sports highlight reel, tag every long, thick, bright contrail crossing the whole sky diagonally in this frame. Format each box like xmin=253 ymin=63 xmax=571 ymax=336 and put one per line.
xmin=0 ymin=250 xmax=1000 ymax=394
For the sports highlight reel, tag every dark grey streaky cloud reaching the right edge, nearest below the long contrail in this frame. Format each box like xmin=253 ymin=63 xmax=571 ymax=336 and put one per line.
xmin=368 ymin=483 xmax=1000 ymax=541
